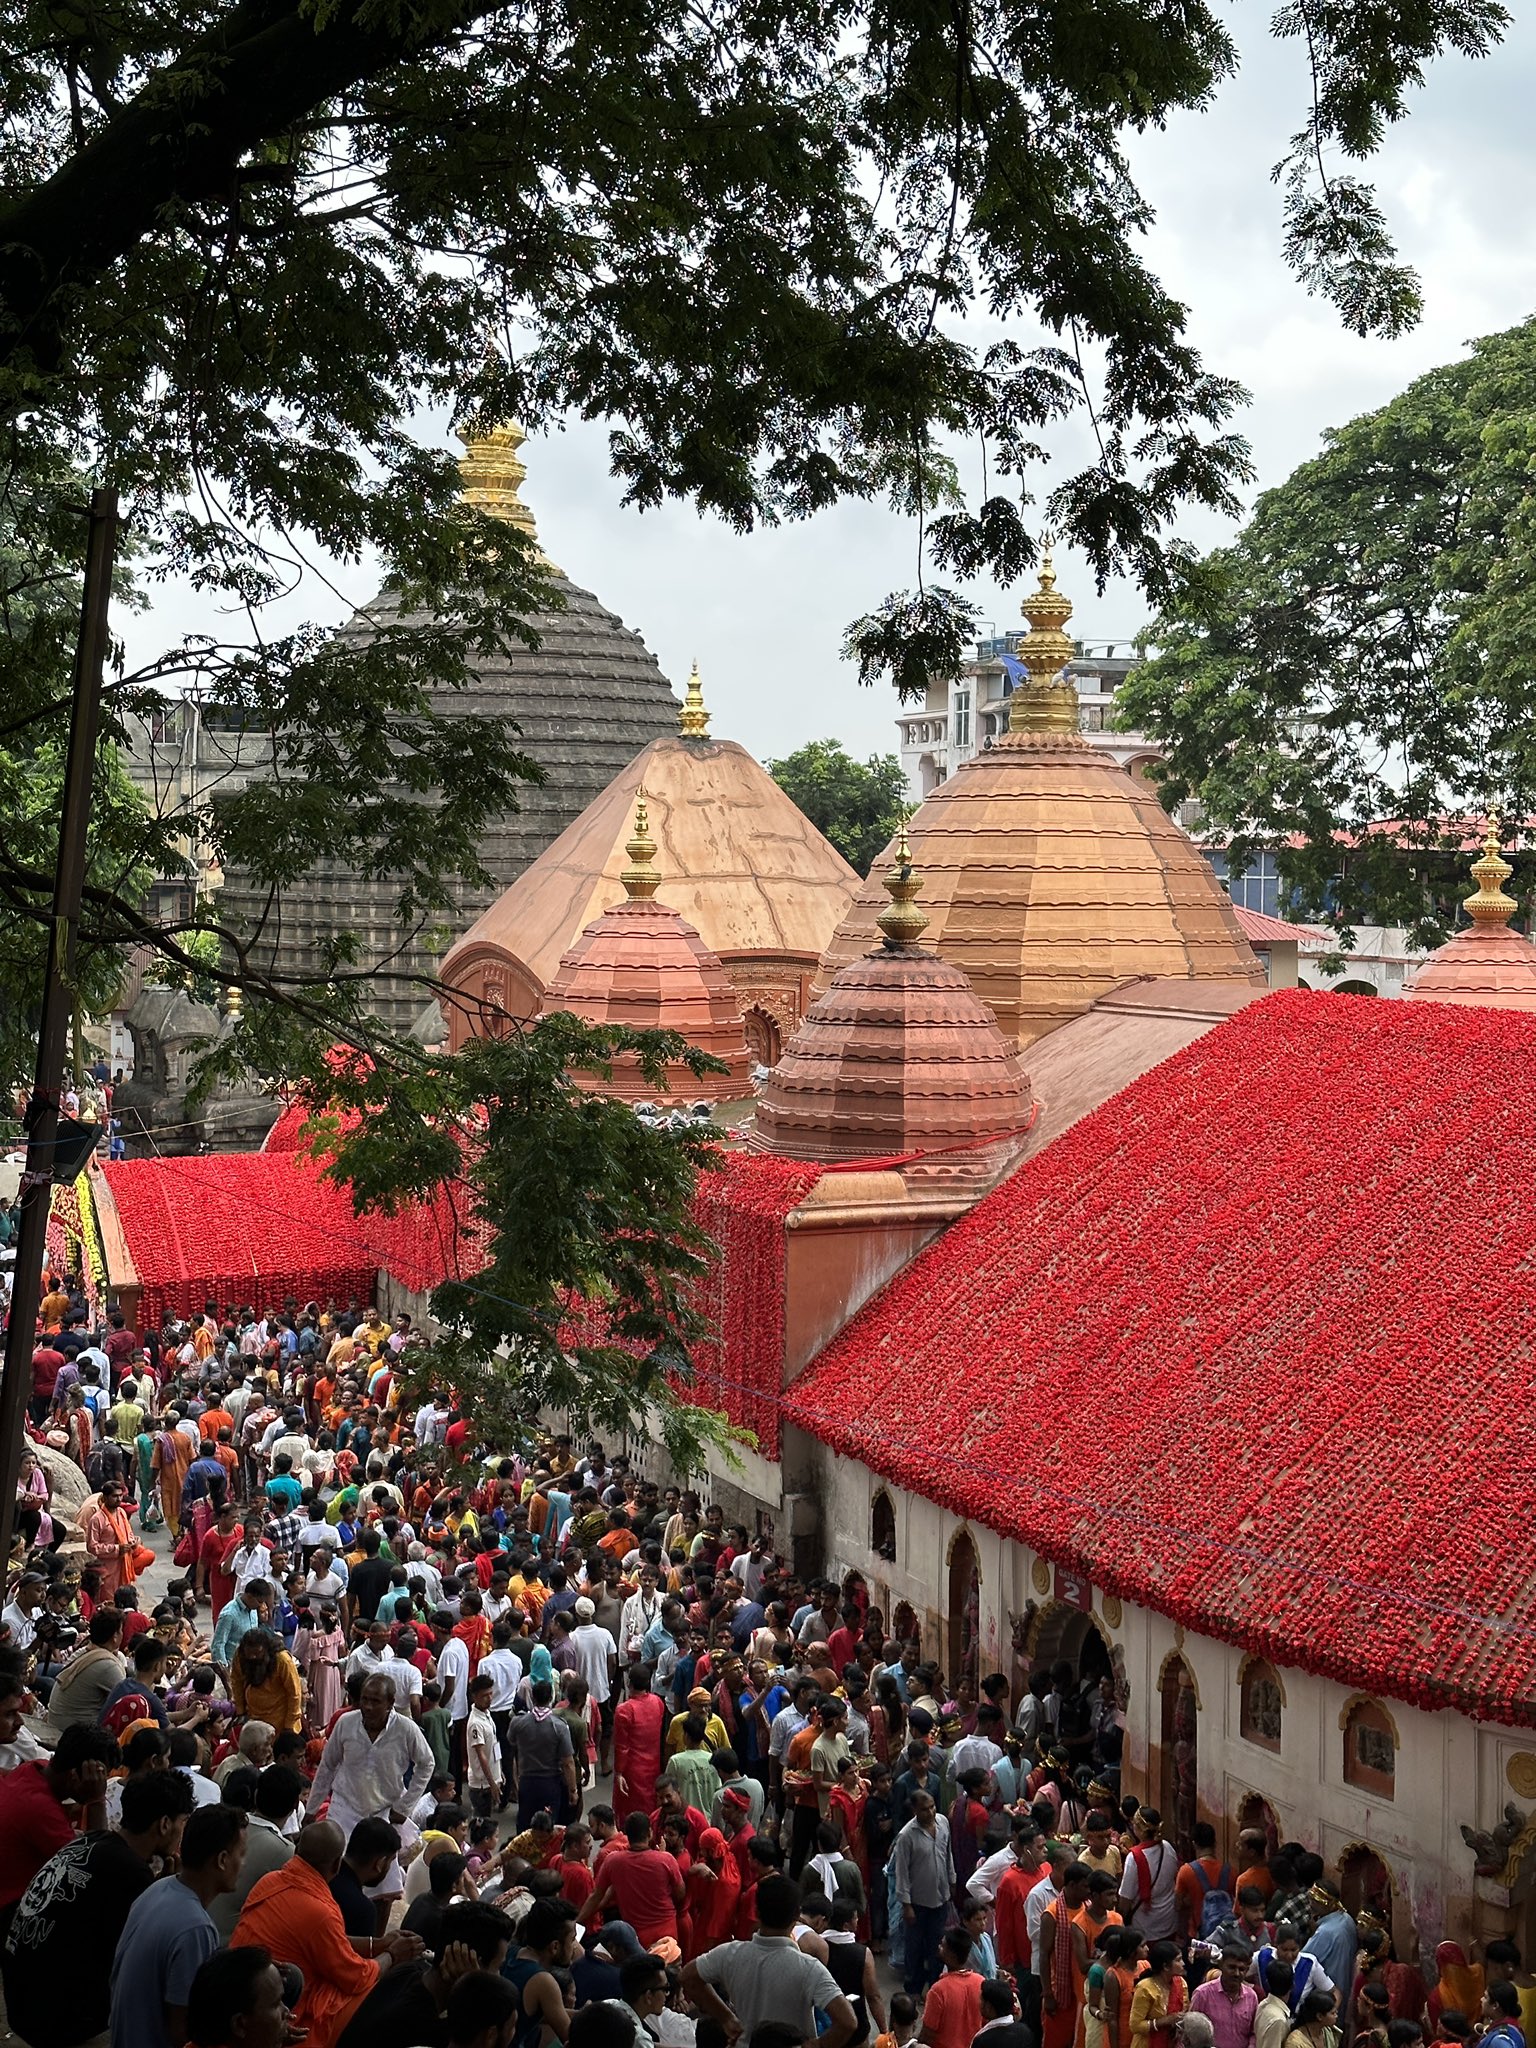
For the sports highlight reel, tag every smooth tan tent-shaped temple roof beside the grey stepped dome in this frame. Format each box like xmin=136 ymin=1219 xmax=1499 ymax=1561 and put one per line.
xmin=440 ymin=672 xmax=858 ymax=1065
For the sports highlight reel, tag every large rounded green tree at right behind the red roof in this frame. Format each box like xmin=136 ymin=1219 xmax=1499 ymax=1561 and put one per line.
xmin=1118 ymin=322 xmax=1536 ymax=944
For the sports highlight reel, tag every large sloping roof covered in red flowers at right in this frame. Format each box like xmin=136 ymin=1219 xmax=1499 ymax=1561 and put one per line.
xmin=784 ymin=991 xmax=1536 ymax=1724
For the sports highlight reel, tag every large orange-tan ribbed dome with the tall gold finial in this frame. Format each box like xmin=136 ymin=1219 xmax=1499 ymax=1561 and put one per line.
xmin=815 ymin=557 xmax=1264 ymax=1049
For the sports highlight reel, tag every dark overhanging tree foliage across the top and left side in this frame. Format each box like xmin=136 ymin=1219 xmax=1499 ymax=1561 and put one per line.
xmin=0 ymin=0 xmax=1505 ymax=1433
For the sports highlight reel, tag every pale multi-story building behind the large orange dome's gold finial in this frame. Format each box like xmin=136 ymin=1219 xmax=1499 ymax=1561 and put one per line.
xmin=897 ymin=629 xmax=1157 ymax=797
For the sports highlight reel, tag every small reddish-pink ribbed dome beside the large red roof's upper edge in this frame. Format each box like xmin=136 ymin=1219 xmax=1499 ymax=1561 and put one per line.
xmin=754 ymin=836 xmax=1030 ymax=1161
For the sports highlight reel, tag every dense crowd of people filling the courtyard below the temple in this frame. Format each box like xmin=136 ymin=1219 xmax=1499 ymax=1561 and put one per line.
xmin=0 ymin=1278 xmax=1536 ymax=2048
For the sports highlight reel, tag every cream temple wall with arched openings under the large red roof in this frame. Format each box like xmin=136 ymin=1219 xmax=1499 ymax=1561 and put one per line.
xmin=768 ymin=1407 xmax=1536 ymax=1962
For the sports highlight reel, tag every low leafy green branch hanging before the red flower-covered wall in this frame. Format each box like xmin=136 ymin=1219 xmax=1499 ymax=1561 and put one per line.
xmin=299 ymin=1012 xmax=731 ymax=1470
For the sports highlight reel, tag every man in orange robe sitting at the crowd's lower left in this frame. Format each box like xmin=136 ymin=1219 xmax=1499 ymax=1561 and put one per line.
xmin=229 ymin=1821 xmax=422 ymax=2048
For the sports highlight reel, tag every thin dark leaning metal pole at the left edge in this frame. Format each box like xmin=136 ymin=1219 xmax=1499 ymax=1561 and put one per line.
xmin=0 ymin=492 xmax=117 ymax=1569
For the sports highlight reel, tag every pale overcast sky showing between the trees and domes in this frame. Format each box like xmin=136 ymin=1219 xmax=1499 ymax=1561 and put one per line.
xmin=131 ymin=4 xmax=1536 ymax=774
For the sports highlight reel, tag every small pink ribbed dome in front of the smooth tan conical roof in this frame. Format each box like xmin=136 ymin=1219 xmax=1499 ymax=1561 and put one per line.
xmin=543 ymin=797 xmax=752 ymax=1104
